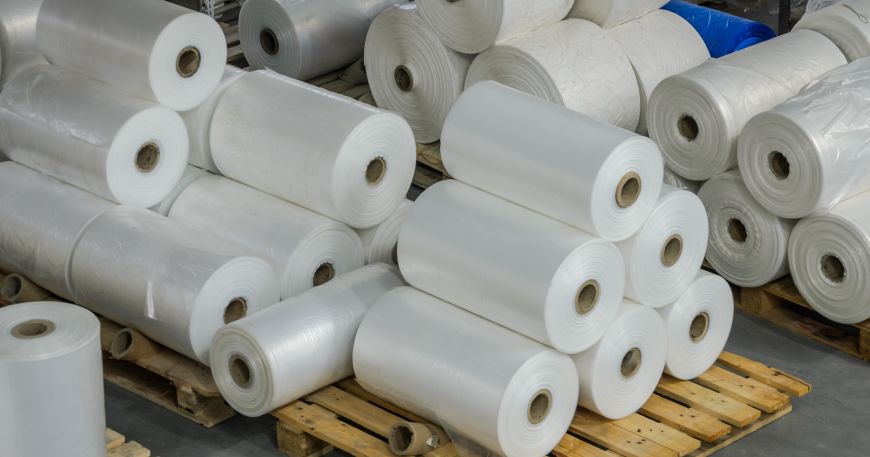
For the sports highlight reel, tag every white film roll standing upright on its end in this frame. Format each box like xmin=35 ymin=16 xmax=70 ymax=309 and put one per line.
xmin=0 ymin=302 xmax=106 ymax=457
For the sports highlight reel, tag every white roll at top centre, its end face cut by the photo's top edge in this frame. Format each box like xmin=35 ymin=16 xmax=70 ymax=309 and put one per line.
xmin=417 ymin=0 xmax=574 ymax=54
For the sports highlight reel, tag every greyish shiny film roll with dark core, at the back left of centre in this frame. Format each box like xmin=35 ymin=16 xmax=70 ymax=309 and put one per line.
xmin=239 ymin=0 xmax=404 ymax=80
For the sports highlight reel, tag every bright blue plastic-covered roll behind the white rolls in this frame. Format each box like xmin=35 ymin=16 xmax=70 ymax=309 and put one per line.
xmin=662 ymin=0 xmax=776 ymax=57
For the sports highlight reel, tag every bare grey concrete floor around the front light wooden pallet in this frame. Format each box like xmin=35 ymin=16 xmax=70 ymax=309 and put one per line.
xmin=106 ymin=312 xmax=870 ymax=457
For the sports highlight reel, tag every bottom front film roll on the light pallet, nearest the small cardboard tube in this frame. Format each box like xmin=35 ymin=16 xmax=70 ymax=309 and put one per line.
xmin=353 ymin=287 xmax=578 ymax=457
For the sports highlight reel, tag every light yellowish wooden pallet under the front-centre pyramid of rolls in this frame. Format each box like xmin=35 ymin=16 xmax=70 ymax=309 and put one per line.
xmin=272 ymin=352 xmax=811 ymax=457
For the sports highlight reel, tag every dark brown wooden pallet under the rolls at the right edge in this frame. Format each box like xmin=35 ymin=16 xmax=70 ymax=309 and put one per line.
xmin=736 ymin=277 xmax=870 ymax=361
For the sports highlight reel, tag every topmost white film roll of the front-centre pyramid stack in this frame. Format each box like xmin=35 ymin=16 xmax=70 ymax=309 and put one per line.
xmin=441 ymin=82 xmax=663 ymax=240
